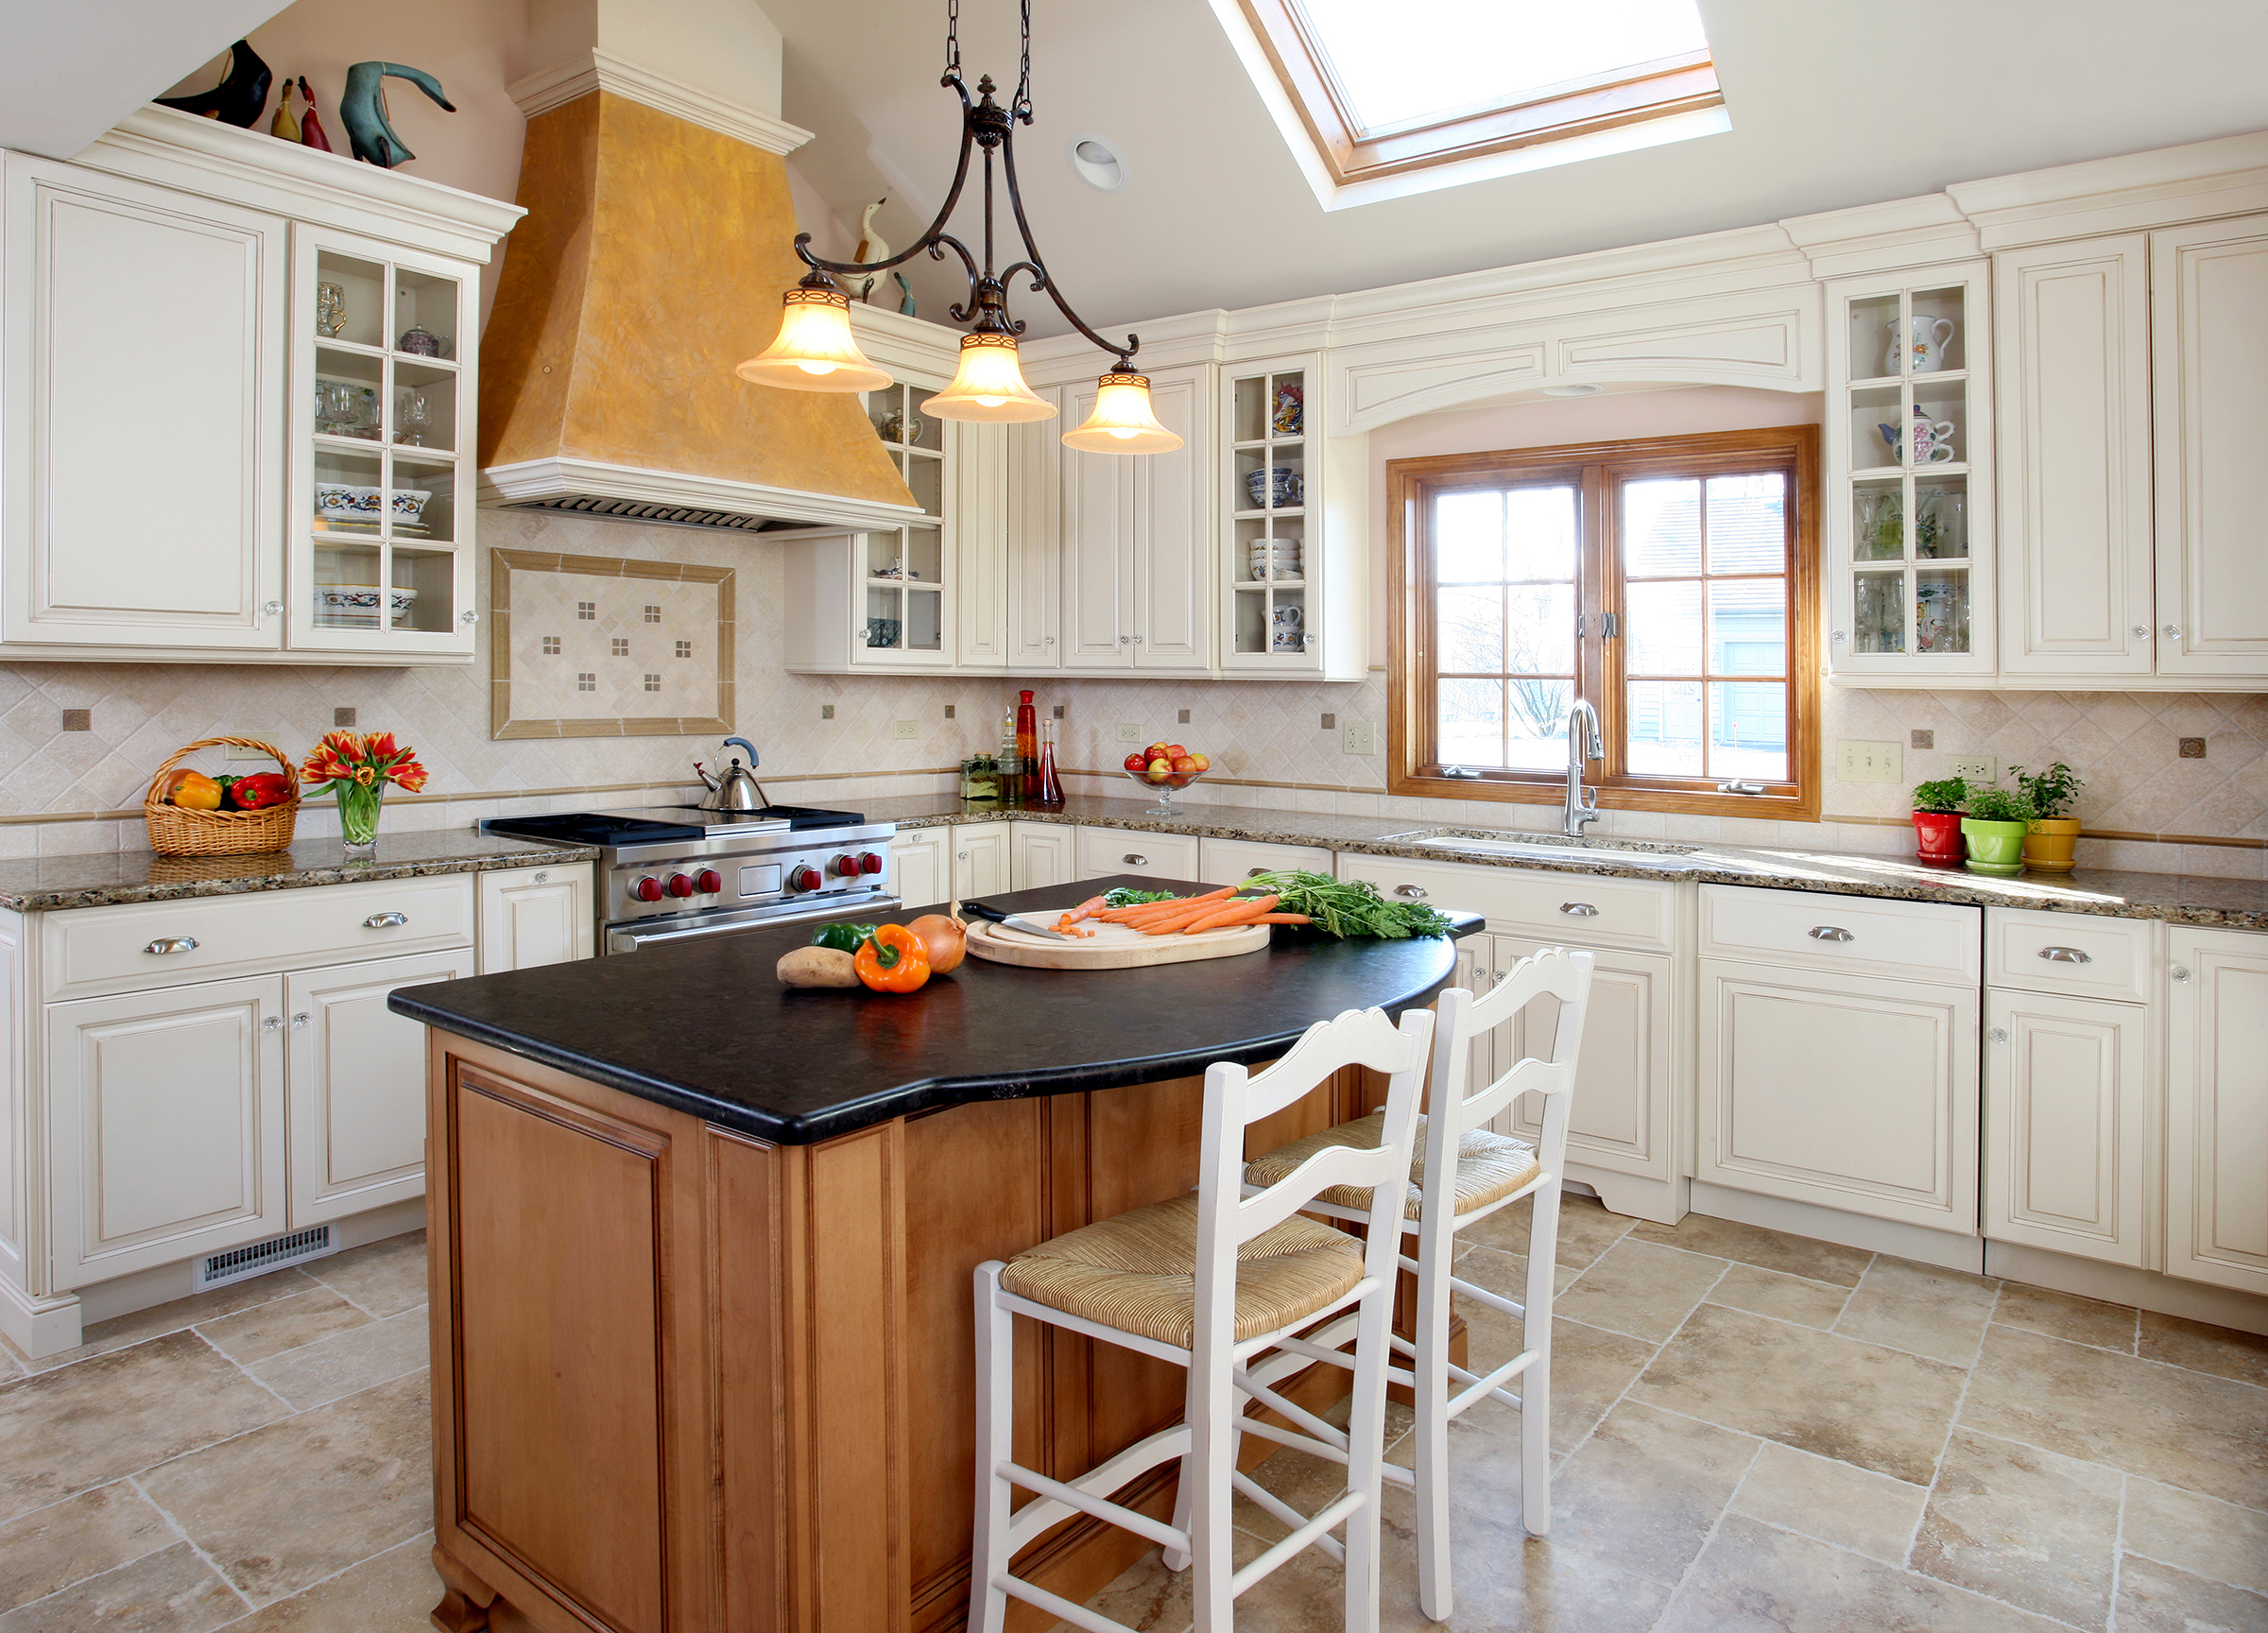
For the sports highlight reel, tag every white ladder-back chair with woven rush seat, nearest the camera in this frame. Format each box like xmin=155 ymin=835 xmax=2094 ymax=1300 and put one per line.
xmin=969 ymin=1009 xmax=1434 ymax=1633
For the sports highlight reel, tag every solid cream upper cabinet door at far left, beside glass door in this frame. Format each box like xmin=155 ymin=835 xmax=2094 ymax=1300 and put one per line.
xmin=5 ymin=154 xmax=288 ymax=651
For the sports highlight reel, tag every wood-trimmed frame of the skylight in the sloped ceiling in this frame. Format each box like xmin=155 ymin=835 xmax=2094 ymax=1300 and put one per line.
xmin=1236 ymin=0 xmax=1724 ymax=186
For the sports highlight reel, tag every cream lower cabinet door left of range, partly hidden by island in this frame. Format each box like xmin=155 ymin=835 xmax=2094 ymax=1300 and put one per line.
xmin=284 ymin=948 xmax=474 ymax=1229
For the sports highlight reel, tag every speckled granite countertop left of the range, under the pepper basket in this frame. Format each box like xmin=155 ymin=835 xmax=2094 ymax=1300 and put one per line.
xmin=0 ymin=830 xmax=599 ymax=912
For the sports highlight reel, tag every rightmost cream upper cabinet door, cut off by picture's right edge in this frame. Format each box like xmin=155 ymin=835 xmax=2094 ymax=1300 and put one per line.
xmin=2150 ymin=215 xmax=2268 ymax=676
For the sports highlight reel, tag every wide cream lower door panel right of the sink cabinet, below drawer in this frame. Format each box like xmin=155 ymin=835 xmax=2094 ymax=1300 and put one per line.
xmin=1694 ymin=959 xmax=1980 ymax=1234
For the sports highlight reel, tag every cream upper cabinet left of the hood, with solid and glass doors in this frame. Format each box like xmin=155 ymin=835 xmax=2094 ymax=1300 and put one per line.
xmin=0 ymin=109 xmax=520 ymax=664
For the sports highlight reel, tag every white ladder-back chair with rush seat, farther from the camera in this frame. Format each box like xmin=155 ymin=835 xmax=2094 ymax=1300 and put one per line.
xmin=1231 ymin=948 xmax=1592 ymax=1622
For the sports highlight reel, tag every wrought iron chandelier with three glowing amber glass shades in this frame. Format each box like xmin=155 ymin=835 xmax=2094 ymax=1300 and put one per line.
xmin=735 ymin=0 xmax=1181 ymax=454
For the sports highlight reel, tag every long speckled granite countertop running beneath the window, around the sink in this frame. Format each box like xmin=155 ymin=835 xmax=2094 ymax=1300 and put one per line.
xmin=857 ymin=794 xmax=2268 ymax=930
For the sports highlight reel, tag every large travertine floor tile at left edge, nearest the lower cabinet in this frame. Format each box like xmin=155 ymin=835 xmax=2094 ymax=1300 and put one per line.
xmin=0 ymin=1332 xmax=285 ymax=1520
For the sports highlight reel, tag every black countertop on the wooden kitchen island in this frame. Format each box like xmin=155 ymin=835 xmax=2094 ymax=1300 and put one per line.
xmin=387 ymin=875 xmax=1479 ymax=1145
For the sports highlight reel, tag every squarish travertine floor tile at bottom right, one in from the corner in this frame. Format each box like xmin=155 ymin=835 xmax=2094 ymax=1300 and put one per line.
xmin=1912 ymin=1429 xmax=2125 ymax=1628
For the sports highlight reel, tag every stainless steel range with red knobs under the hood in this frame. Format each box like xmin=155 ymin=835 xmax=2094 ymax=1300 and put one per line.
xmin=481 ymin=805 xmax=905 ymax=953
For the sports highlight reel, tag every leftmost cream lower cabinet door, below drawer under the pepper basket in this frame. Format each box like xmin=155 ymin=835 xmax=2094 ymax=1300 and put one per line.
xmin=47 ymin=975 xmax=284 ymax=1288
